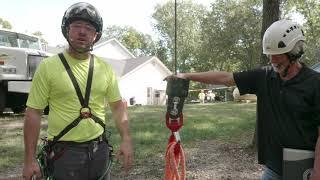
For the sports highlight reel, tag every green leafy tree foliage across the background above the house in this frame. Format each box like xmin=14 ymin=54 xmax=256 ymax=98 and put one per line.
xmin=0 ymin=0 xmax=320 ymax=72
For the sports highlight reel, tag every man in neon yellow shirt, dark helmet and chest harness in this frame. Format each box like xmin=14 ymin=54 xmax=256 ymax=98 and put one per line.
xmin=23 ymin=2 xmax=133 ymax=180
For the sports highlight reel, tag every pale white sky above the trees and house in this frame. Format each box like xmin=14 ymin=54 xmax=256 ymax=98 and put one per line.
xmin=0 ymin=0 xmax=214 ymax=46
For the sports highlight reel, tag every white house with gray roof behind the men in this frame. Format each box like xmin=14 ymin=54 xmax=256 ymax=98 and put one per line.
xmin=93 ymin=39 xmax=172 ymax=105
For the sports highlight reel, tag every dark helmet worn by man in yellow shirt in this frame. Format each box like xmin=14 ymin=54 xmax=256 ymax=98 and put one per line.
xmin=61 ymin=2 xmax=103 ymax=43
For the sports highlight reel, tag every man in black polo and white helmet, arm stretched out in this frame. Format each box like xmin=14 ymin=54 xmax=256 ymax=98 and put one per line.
xmin=168 ymin=20 xmax=320 ymax=180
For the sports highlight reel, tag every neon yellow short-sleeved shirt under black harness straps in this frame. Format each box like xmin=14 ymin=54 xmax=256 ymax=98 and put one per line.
xmin=27 ymin=51 xmax=121 ymax=142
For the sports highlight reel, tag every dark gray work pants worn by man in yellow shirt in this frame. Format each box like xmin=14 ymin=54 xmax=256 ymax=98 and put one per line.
xmin=53 ymin=141 xmax=110 ymax=180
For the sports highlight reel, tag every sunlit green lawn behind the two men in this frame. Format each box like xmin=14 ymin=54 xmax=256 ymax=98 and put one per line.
xmin=0 ymin=102 xmax=256 ymax=174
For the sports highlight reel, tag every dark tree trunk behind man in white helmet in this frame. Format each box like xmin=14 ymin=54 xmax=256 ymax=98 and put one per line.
xmin=252 ymin=0 xmax=281 ymax=148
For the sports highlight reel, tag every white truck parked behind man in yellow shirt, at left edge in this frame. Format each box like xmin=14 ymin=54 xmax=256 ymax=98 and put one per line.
xmin=0 ymin=29 xmax=50 ymax=113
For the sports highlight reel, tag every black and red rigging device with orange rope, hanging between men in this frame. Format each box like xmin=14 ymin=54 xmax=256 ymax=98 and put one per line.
xmin=165 ymin=79 xmax=189 ymax=180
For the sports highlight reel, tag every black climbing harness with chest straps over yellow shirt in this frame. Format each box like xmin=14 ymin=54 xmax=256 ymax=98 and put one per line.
xmin=37 ymin=53 xmax=113 ymax=180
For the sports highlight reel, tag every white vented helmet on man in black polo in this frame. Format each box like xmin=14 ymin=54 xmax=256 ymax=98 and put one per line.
xmin=262 ymin=20 xmax=305 ymax=55
